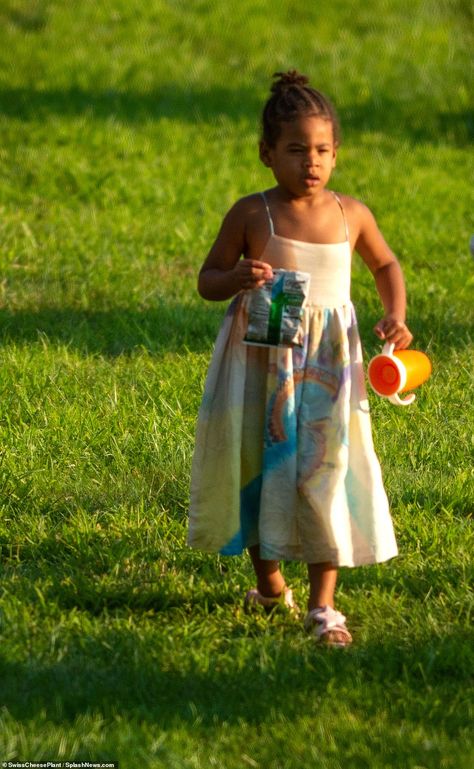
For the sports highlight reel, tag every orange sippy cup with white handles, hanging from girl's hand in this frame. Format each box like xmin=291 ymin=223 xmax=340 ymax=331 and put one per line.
xmin=367 ymin=344 xmax=431 ymax=406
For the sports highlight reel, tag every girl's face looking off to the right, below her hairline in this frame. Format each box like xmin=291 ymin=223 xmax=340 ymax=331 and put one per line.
xmin=260 ymin=115 xmax=336 ymax=197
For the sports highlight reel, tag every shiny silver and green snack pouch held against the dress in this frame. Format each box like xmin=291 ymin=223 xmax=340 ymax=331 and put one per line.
xmin=244 ymin=270 xmax=311 ymax=347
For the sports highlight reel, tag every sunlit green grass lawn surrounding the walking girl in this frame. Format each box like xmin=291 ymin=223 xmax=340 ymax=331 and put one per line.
xmin=0 ymin=0 xmax=474 ymax=769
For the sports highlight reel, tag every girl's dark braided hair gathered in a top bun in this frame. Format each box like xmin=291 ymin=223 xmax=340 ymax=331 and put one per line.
xmin=262 ymin=69 xmax=341 ymax=147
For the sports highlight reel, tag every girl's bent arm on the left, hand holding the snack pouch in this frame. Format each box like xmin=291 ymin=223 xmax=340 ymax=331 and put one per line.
xmin=198 ymin=198 xmax=272 ymax=301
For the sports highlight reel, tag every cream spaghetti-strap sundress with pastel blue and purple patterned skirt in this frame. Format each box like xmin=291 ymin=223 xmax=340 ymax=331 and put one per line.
xmin=188 ymin=193 xmax=397 ymax=566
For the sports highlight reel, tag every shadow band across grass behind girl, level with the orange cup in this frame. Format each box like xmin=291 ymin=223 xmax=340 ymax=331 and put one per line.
xmin=0 ymin=301 xmax=472 ymax=358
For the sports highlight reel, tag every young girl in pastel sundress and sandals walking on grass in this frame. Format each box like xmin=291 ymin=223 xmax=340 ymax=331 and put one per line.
xmin=188 ymin=71 xmax=412 ymax=646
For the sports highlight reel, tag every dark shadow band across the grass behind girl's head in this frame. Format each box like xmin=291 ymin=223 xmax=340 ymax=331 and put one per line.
xmin=0 ymin=84 xmax=474 ymax=146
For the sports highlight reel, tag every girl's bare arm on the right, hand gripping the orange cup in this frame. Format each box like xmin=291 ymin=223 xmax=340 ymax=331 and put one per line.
xmin=354 ymin=201 xmax=413 ymax=349
